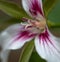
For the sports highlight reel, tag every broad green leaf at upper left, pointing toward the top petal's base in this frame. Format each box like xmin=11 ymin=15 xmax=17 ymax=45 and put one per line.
xmin=0 ymin=1 xmax=29 ymax=19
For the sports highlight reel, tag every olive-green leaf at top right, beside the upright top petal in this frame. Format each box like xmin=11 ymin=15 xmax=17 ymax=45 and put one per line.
xmin=43 ymin=0 xmax=58 ymax=16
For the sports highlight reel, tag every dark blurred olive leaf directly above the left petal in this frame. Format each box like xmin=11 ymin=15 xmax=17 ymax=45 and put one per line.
xmin=0 ymin=18 xmax=21 ymax=31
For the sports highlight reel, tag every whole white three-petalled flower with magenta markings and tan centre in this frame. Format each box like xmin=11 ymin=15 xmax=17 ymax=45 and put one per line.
xmin=1 ymin=0 xmax=60 ymax=62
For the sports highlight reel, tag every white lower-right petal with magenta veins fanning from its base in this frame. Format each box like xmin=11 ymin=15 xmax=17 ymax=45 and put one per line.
xmin=35 ymin=28 xmax=60 ymax=62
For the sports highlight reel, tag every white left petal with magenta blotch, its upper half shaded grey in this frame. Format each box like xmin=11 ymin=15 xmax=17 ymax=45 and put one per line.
xmin=1 ymin=24 xmax=34 ymax=49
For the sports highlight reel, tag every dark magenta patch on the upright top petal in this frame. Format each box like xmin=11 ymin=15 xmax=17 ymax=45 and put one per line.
xmin=29 ymin=0 xmax=43 ymax=16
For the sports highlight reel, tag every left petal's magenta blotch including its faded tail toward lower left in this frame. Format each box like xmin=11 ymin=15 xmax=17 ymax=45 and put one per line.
xmin=9 ymin=31 xmax=36 ymax=45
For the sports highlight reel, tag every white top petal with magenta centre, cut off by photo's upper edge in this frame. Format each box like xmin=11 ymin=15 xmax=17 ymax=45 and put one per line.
xmin=22 ymin=0 xmax=44 ymax=18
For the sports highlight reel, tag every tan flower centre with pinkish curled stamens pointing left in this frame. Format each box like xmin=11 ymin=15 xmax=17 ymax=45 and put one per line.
xmin=22 ymin=18 xmax=46 ymax=32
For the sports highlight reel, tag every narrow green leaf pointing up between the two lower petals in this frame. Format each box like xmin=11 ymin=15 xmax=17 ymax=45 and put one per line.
xmin=19 ymin=41 xmax=34 ymax=62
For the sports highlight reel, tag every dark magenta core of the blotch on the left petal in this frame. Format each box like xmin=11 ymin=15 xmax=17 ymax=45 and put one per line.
xmin=15 ymin=31 xmax=36 ymax=41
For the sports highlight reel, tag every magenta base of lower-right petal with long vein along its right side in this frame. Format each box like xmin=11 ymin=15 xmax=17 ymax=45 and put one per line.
xmin=39 ymin=30 xmax=59 ymax=52
